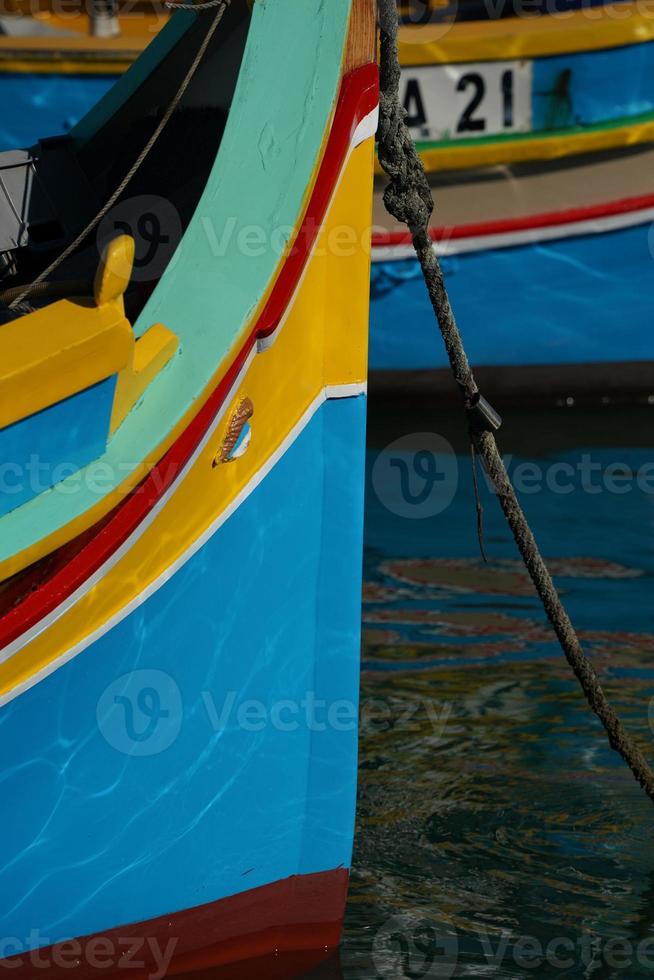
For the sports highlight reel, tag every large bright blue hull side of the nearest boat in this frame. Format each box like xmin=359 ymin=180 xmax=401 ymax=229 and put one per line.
xmin=0 ymin=397 xmax=365 ymax=955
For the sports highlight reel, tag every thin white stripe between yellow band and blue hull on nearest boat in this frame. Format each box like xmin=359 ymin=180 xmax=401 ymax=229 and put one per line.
xmin=0 ymin=382 xmax=367 ymax=707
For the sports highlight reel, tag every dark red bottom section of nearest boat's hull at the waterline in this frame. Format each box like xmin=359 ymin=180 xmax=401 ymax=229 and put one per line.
xmin=0 ymin=868 xmax=349 ymax=980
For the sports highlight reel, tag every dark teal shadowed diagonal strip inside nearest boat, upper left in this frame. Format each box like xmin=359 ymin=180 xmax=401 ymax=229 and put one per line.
xmin=71 ymin=10 xmax=198 ymax=146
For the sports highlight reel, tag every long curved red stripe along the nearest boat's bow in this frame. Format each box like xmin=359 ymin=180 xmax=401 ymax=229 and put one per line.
xmin=0 ymin=64 xmax=379 ymax=650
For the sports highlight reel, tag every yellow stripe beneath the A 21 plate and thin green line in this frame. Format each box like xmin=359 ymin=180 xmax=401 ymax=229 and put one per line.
xmin=376 ymin=120 xmax=654 ymax=174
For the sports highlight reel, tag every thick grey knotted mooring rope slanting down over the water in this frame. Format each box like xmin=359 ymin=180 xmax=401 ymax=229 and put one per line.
xmin=377 ymin=0 xmax=654 ymax=802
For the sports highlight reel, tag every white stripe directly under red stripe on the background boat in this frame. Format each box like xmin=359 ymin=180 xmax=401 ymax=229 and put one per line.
xmin=372 ymin=208 xmax=654 ymax=262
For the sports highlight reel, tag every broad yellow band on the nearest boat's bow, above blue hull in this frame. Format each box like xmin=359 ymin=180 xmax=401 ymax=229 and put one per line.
xmin=0 ymin=140 xmax=373 ymax=696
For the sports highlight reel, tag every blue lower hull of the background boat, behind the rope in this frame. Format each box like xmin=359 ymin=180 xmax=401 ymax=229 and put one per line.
xmin=370 ymin=225 xmax=654 ymax=371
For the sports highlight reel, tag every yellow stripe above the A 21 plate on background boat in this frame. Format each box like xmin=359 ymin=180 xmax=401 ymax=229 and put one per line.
xmin=400 ymin=2 xmax=654 ymax=66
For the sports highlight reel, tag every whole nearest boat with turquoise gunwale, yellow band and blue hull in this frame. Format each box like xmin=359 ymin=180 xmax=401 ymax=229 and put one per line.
xmin=0 ymin=0 xmax=378 ymax=978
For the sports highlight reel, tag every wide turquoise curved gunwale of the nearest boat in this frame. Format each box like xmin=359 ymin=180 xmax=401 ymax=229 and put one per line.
xmin=0 ymin=0 xmax=351 ymax=561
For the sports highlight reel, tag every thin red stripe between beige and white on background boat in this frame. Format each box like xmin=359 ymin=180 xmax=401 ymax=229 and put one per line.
xmin=372 ymin=194 xmax=654 ymax=248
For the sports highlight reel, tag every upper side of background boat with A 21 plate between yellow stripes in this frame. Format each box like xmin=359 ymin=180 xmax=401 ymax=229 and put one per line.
xmin=400 ymin=0 xmax=654 ymax=171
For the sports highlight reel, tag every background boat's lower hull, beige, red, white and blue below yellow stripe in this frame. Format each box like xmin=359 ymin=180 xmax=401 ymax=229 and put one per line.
xmin=370 ymin=148 xmax=654 ymax=402
